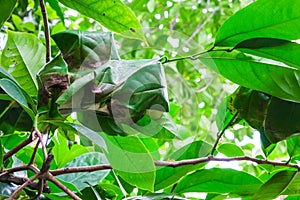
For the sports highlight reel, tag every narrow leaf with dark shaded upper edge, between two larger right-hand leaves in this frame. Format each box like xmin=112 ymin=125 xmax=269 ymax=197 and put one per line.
xmin=235 ymin=38 xmax=300 ymax=70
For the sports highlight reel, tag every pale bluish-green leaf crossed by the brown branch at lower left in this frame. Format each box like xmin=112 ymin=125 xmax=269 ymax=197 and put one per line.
xmin=57 ymin=152 xmax=109 ymax=190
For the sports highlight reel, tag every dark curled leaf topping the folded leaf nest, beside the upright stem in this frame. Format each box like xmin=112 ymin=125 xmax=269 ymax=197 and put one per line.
xmin=52 ymin=30 xmax=120 ymax=72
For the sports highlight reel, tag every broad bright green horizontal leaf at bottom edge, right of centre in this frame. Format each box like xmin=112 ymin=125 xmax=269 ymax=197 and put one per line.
xmin=174 ymin=168 xmax=262 ymax=196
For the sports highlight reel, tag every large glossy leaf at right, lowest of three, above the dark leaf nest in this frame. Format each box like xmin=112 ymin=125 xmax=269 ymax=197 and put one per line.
xmin=200 ymin=51 xmax=300 ymax=102
